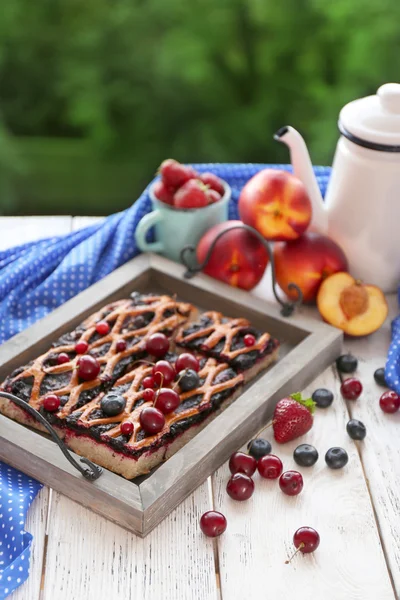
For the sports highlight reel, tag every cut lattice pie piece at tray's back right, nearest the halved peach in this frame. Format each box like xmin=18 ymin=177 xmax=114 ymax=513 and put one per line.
xmin=175 ymin=311 xmax=279 ymax=381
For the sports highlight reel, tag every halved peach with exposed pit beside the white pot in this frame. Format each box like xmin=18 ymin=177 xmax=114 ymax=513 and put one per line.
xmin=317 ymin=272 xmax=388 ymax=336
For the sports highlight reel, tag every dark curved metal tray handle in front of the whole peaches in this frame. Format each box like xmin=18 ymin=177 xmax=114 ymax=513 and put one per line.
xmin=181 ymin=223 xmax=303 ymax=317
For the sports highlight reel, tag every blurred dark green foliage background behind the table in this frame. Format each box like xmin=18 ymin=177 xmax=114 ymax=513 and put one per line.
xmin=0 ymin=0 xmax=400 ymax=214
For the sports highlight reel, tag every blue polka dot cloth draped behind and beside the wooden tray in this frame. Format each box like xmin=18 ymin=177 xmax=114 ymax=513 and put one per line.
xmin=0 ymin=164 xmax=330 ymax=600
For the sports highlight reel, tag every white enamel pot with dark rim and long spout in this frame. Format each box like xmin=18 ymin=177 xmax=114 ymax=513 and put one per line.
xmin=275 ymin=83 xmax=400 ymax=292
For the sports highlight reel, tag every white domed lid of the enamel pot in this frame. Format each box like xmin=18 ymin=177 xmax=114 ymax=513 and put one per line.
xmin=339 ymin=83 xmax=400 ymax=152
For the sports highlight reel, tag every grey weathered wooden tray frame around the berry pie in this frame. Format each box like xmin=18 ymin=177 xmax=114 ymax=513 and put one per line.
xmin=0 ymin=254 xmax=342 ymax=537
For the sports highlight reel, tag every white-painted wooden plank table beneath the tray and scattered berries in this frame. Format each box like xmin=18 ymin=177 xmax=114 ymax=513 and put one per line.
xmin=0 ymin=217 xmax=400 ymax=600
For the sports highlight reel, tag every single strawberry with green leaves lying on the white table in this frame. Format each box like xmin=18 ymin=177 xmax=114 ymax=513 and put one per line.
xmin=272 ymin=393 xmax=315 ymax=444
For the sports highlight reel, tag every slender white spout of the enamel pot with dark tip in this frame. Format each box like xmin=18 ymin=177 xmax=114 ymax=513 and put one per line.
xmin=274 ymin=126 xmax=328 ymax=234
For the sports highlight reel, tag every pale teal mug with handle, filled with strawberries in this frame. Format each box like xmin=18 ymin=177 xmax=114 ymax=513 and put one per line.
xmin=135 ymin=182 xmax=231 ymax=262
